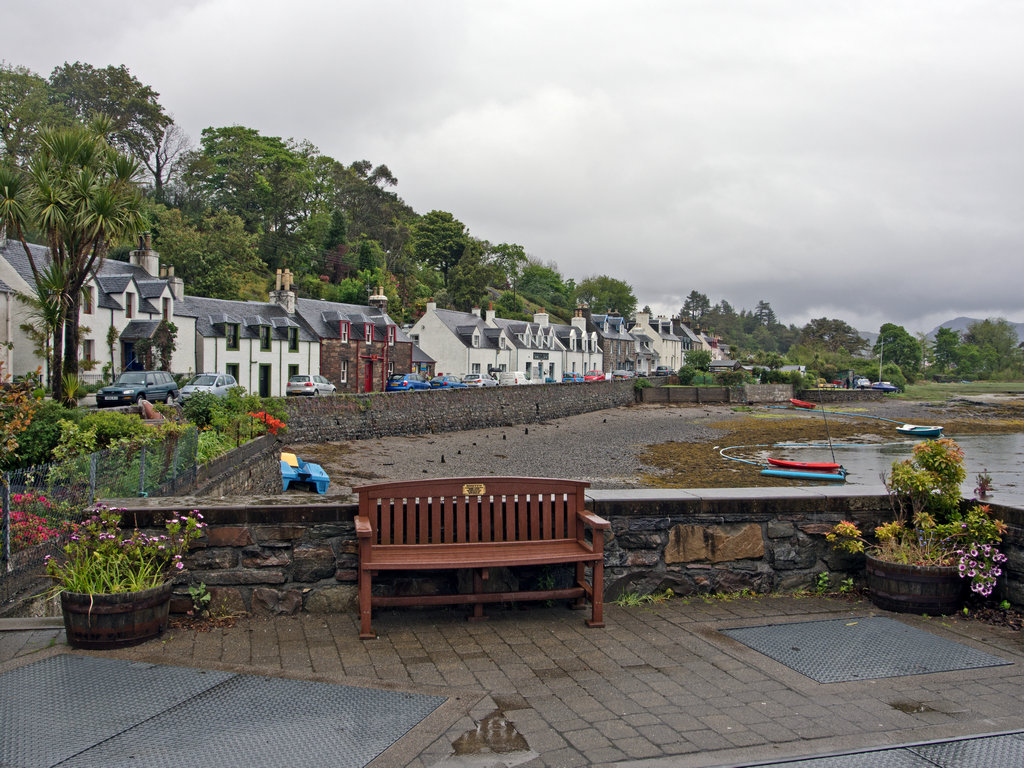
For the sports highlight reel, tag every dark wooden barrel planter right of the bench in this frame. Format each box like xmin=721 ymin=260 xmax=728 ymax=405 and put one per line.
xmin=864 ymin=555 xmax=968 ymax=615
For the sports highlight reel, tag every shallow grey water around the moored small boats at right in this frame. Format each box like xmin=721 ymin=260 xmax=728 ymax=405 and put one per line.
xmin=770 ymin=433 xmax=1024 ymax=504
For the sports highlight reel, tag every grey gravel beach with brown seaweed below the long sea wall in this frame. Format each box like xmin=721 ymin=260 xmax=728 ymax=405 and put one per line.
xmin=286 ymin=398 xmax=1024 ymax=501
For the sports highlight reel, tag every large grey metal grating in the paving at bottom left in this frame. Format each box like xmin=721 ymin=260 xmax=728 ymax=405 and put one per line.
xmin=0 ymin=655 xmax=444 ymax=768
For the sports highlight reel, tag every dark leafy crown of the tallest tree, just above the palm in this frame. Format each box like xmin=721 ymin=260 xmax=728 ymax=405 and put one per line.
xmin=50 ymin=61 xmax=173 ymax=170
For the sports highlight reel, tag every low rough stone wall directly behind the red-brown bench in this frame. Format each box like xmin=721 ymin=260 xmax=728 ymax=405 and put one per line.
xmin=117 ymin=488 xmax=1024 ymax=614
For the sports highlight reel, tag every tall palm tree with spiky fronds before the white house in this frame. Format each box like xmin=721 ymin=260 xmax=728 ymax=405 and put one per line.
xmin=0 ymin=118 xmax=144 ymax=400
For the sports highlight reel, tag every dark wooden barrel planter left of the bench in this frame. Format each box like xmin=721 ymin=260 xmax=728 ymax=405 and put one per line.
xmin=60 ymin=581 xmax=174 ymax=649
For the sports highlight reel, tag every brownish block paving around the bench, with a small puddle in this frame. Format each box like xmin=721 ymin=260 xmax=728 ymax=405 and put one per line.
xmin=0 ymin=597 xmax=1024 ymax=768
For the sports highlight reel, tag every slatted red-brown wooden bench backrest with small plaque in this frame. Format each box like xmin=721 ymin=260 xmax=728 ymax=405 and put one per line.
xmin=354 ymin=477 xmax=590 ymax=545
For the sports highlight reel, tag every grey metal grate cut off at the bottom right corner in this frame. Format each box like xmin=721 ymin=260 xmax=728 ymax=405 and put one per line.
xmin=739 ymin=732 xmax=1024 ymax=768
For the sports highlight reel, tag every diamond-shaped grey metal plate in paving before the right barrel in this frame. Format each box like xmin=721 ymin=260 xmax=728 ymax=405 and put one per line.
xmin=722 ymin=616 xmax=1011 ymax=683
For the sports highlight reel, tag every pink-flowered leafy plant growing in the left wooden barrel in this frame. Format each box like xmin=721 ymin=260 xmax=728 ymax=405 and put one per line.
xmin=46 ymin=504 xmax=206 ymax=594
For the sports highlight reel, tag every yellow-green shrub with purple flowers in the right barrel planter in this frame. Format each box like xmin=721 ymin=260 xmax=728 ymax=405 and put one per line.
xmin=825 ymin=438 xmax=1007 ymax=597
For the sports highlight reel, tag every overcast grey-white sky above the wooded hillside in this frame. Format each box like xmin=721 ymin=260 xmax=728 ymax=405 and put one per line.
xmin=0 ymin=0 xmax=1024 ymax=332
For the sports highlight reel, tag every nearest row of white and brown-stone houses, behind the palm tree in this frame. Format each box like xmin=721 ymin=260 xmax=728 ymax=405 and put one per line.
xmin=0 ymin=237 xmax=417 ymax=396
